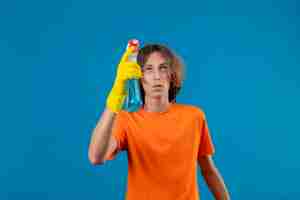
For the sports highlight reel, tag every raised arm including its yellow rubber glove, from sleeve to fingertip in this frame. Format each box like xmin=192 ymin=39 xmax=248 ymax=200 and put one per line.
xmin=88 ymin=41 xmax=142 ymax=165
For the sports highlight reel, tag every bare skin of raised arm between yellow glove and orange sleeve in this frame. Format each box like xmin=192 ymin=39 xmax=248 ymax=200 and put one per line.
xmin=88 ymin=108 xmax=117 ymax=165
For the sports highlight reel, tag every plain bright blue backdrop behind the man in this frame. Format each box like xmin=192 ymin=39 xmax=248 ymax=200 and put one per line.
xmin=0 ymin=0 xmax=300 ymax=200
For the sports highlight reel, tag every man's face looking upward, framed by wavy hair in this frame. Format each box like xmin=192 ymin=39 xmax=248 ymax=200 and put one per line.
xmin=141 ymin=52 xmax=171 ymax=98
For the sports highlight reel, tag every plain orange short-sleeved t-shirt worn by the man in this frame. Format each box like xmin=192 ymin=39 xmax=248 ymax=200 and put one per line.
xmin=107 ymin=103 xmax=215 ymax=200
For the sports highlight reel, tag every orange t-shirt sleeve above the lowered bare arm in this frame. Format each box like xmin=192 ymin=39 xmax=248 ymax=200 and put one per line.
xmin=198 ymin=109 xmax=215 ymax=158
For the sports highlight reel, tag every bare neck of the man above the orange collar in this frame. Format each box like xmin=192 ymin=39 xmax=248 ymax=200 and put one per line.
xmin=144 ymin=96 xmax=170 ymax=112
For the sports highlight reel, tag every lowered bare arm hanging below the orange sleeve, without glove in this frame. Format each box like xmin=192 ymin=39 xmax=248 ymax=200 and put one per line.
xmin=198 ymin=155 xmax=230 ymax=200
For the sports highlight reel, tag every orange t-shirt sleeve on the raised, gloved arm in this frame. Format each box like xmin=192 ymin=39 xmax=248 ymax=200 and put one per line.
xmin=106 ymin=111 xmax=127 ymax=160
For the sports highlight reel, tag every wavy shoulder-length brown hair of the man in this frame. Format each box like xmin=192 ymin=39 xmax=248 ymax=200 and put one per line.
xmin=137 ymin=44 xmax=184 ymax=103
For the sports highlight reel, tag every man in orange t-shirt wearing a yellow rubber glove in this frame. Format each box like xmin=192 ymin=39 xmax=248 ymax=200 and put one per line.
xmin=89 ymin=44 xmax=230 ymax=200
